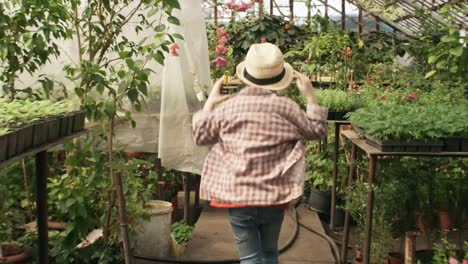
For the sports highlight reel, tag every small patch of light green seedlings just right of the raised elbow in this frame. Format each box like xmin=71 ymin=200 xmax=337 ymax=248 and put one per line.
xmin=315 ymin=89 xmax=362 ymax=112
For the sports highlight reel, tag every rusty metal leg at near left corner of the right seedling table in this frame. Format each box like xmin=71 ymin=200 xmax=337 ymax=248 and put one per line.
xmin=364 ymin=155 xmax=377 ymax=264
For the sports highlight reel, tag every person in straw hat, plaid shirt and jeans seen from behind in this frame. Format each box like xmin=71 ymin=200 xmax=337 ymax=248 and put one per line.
xmin=193 ymin=43 xmax=327 ymax=264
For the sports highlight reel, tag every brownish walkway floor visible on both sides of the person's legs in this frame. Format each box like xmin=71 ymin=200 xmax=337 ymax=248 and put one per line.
xmin=181 ymin=206 xmax=335 ymax=264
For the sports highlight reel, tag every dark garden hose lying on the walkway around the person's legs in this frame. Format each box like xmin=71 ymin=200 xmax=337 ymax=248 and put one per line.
xmin=134 ymin=200 xmax=341 ymax=264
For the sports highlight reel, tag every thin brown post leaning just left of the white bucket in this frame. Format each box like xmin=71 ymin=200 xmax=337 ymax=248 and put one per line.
xmin=114 ymin=172 xmax=132 ymax=264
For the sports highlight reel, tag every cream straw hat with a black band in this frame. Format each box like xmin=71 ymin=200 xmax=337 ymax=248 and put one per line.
xmin=236 ymin=43 xmax=293 ymax=91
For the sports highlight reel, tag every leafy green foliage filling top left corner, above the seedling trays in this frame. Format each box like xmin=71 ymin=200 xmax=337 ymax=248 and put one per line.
xmin=0 ymin=0 xmax=71 ymax=99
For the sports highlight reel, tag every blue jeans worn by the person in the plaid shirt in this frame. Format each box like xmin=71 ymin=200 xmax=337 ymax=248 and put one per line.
xmin=229 ymin=207 xmax=284 ymax=264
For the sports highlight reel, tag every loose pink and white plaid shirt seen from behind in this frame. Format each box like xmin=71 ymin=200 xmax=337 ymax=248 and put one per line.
xmin=193 ymin=87 xmax=328 ymax=206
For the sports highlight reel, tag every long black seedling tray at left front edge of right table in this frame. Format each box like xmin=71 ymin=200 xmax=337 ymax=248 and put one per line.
xmin=353 ymin=127 xmax=444 ymax=152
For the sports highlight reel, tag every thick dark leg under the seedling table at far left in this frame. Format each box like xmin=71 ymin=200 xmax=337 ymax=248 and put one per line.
xmin=36 ymin=151 xmax=49 ymax=264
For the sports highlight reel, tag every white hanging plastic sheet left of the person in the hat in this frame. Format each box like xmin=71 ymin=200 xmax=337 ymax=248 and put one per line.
xmin=158 ymin=0 xmax=211 ymax=174
